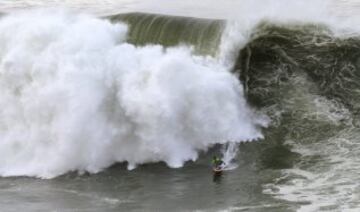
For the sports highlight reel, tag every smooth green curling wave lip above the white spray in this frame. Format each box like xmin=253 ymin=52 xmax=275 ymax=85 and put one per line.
xmin=109 ymin=13 xmax=225 ymax=56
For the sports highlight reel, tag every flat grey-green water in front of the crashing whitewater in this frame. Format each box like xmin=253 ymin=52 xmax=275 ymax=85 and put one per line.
xmin=0 ymin=153 xmax=290 ymax=211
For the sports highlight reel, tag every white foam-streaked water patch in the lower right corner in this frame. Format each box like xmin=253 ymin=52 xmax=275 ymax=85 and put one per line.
xmin=264 ymin=129 xmax=360 ymax=212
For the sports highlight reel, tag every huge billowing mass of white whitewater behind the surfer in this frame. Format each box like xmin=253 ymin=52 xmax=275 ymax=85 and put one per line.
xmin=0 ymin=10 xmax=262 ymax=178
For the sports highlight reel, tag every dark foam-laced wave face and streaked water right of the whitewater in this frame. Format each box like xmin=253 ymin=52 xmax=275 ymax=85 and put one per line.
xmin=235 ymin=22 xmax=360 ymax=211
